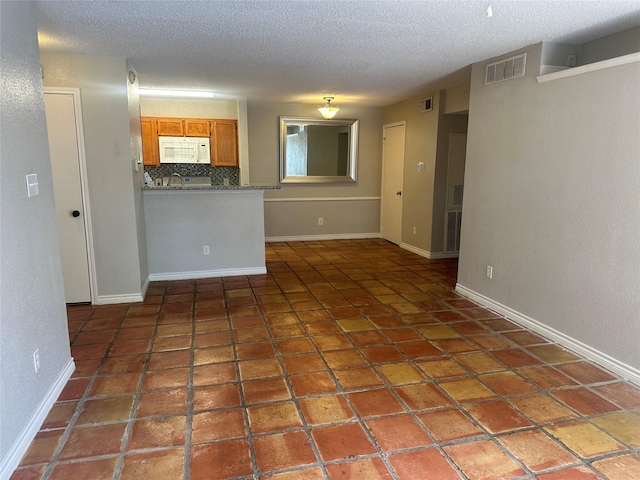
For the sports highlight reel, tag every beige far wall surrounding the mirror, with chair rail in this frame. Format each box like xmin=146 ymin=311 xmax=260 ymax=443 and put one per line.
xmin=248 ymin=103 xmax=382 ymax=239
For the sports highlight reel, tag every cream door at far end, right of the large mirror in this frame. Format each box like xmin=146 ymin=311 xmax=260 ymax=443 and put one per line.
xmin=380 ymin=122 xmax=405 ymax=245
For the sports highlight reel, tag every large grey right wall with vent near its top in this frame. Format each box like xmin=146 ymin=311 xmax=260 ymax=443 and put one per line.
xmin=458 ymin=44 xmax=640 ymax=378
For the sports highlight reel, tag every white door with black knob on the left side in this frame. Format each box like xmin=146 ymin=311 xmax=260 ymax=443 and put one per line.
xmin=44 ymin=91 xmax=91 ymax=303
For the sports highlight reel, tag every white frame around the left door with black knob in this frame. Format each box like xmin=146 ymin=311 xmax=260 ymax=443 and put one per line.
xmin=43 ymin=87 xmax=98 ymax=305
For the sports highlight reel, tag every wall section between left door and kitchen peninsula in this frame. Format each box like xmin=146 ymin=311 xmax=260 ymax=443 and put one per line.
xmin=41 ymin=53 xmax=146 ymax=302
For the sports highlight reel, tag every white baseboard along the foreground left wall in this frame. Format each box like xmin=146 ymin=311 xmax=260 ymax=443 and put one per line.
xmin=0 ymin=358 xmax=76 ymax=480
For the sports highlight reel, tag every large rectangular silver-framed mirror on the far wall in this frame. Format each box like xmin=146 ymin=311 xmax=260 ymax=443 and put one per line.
xmin=280 ymin=116 xmax=358 ymax=183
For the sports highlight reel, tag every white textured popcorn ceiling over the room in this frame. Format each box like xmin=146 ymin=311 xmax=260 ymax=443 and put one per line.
xmin=36 ymin=0 xmax=640 ymax=106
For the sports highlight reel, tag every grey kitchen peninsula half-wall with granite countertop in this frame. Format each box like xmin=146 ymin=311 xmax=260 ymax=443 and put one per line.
xmin=143 ymin=185 xmax=280 ymax=281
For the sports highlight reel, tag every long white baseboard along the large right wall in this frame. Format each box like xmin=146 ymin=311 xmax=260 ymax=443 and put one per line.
xmin=456 ymin=283 xmax=640 ymax=385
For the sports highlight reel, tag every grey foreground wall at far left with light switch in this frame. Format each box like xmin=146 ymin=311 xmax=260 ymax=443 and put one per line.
xmin=0 ymin=2 xmax=73 ymax=478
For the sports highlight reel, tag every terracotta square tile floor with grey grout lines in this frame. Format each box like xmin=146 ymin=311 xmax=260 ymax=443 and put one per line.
xmin=12 ymin=240 xmax=640 ymax=480
